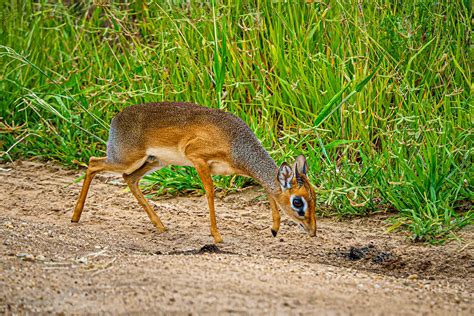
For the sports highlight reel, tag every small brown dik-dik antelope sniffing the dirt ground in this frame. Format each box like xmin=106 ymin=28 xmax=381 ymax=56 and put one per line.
xmin=71 ymin=102 xmax=316 ymax=243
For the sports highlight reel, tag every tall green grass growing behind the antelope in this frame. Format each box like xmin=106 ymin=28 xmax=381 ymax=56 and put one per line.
xmin=0 ymin=0 xmax=474 ymax=243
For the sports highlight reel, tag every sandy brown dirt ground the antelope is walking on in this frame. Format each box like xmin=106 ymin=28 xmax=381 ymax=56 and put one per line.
xmin=0 ymin=162 xmax=474 ymax=315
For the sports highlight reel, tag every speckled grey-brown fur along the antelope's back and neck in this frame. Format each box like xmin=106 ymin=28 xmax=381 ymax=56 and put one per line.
xmin=107 ymin=102 xmax=278 ymax=193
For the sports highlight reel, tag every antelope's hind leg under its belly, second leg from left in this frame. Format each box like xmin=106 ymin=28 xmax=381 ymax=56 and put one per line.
xmin=123 ymin=161 xmax=166 ymax=233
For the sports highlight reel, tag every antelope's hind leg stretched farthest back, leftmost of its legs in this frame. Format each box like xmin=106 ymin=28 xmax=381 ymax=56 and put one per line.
xmin=71 ymin=157 xmax=124 ymax=223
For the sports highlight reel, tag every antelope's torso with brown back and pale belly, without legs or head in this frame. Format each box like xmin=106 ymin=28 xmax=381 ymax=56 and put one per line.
xmin=107 ymin=102 xmax=266 ymax=177
